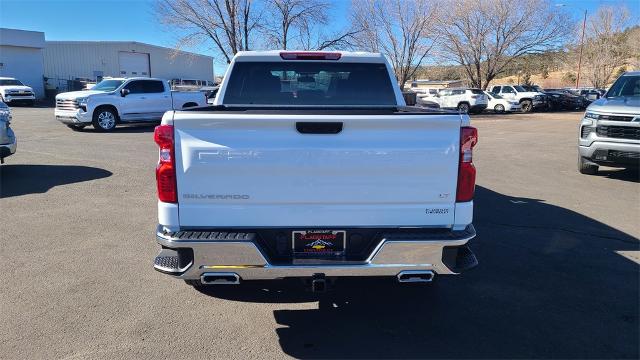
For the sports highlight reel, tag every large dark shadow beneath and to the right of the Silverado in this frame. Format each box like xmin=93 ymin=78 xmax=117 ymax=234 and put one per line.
xmin=198 ymin=187 xmax=640 ymax=359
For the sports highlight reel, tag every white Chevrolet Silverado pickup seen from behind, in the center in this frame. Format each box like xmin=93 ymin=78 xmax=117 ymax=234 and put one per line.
xmin=154 ymin=51 xmax=477 ymax=291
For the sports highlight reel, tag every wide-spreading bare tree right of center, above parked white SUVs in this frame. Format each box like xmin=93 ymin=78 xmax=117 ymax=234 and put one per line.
xmin=439 ymin=0 xmax=573 ymax=89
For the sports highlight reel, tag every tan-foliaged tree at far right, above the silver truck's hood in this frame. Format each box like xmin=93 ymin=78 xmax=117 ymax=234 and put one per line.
xmin=582 ymin=6 xmax=633 ymax=88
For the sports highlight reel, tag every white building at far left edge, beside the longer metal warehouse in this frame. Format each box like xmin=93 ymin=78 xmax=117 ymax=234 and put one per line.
xmin=0 ymin=28 xmax=45 ymax=98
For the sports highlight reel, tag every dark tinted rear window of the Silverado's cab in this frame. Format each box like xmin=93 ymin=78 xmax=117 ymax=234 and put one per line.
xmin=223 ymin=61 xmax=397 ymax=106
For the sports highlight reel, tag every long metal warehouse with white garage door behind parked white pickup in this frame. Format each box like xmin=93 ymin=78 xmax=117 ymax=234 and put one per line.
xmin=44 ymin=41 xmax=214 ymax=90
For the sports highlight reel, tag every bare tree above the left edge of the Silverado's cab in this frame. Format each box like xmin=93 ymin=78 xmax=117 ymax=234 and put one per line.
xmin=156 ymin=0 xmax=259 ymax=61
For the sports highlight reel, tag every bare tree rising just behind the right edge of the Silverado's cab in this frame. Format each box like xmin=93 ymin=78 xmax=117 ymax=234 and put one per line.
xmin=351 ymin=0 xmax=436 ymax=88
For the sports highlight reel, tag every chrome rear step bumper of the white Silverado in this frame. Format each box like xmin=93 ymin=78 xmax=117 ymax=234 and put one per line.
xmin=154 ymin=225 xmax=478 ymax=283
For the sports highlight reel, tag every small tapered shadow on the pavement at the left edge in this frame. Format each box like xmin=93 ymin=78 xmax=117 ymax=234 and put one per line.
xmin=0 ymin=164 xmax=112 ymax=198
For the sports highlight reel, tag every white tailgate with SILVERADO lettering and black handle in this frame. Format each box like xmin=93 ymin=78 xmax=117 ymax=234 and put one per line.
xmin=173 ymin=112 xmax=461 ymax=227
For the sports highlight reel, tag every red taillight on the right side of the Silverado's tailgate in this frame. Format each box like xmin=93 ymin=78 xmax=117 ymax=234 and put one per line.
xmin=456 ymin=126 xmax=478 ymax=202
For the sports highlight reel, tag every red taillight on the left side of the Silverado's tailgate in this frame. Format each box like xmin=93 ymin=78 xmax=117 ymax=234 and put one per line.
xmin=153 ymin=125 xmax=178 ymax=203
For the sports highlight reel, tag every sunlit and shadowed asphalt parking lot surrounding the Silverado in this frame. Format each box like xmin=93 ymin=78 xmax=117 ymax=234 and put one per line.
xmin=0 ymin=108 xmax=640 ymax=359
